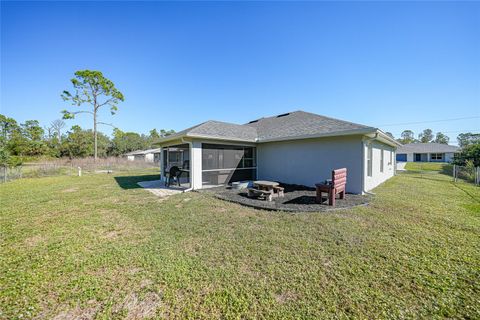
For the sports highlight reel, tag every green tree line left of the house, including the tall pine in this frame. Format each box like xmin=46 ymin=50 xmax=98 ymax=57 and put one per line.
xmin=0 ymin=70 xmax=174 ymax=165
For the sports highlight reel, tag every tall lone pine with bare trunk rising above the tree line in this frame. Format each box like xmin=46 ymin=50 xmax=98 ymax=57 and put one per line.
xmin=61 ymin=70 xmax=124 ymax=160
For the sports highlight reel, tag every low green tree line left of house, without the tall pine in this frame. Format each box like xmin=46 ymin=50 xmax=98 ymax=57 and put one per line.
xmin=0 ymin=114 xmax=174 ymax=165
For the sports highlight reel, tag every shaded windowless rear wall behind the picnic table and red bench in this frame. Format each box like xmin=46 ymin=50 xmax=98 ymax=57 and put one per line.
xmin=257 ymin=136 xmax=363 ymax=193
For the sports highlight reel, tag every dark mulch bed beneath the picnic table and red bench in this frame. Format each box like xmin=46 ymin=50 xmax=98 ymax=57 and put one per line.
xmin=201 ymin=184 xmax=372 ymax=212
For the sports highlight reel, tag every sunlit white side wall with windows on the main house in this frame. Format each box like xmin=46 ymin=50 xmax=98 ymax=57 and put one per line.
xmin=363 ymin=139 xmax=396 ymax=192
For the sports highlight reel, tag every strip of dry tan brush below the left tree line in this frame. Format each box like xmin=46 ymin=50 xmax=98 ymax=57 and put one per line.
xmin=0 ymin=157 xmax=160 ymax=183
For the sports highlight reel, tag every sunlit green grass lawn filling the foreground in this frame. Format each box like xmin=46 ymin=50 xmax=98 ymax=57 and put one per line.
xmin=0 ymin=172 xmax=480 ymax=319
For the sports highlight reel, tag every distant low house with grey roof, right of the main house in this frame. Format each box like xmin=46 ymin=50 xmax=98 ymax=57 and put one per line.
xmin=397 ymin=142 xmax=460 ymax=162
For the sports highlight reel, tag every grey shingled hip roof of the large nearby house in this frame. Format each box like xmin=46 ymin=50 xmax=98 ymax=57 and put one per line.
xmin=159 ymin=111 xmax=397 ymax=144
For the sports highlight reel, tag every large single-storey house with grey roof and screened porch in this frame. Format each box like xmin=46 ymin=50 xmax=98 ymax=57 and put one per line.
xmin=158 ymin=111 xmax=400 ymax=194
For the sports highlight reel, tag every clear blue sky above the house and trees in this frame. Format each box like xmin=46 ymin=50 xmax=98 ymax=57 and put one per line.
xmin=0 ymin=1 xmax=480 ymax=140
